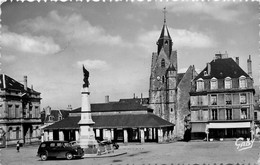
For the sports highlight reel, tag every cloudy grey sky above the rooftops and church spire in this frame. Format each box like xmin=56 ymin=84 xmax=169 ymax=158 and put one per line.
xmin=0 ymin=1 xmax=260 ymax=109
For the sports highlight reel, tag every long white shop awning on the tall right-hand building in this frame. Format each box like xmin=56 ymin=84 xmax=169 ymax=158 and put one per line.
xmin=208 ymin=122 xmax=251 ymax=129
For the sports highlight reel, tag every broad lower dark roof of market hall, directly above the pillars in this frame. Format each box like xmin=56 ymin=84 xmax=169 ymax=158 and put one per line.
xmin=44 ymin=113 xmax=174 ymax=130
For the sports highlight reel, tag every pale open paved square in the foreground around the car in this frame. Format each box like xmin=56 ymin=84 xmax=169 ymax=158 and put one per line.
xmin=0 ymin=141 xmax=260 ymax=165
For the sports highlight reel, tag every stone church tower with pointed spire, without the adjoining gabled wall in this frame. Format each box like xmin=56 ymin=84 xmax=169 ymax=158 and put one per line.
xmin=149 ymin=8 xmax=177 ymax=123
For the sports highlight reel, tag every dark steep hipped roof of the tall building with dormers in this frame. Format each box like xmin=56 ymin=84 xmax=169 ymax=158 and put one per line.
xmin=195 ymin=58 xmax=249 ymax=80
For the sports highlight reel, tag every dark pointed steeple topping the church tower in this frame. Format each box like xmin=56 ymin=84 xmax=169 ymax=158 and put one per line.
xmin=157 ymin=7 xmax=172 ymax=57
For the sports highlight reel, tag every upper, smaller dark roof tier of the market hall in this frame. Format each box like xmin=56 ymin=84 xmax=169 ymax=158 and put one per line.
xmin=71 ymin=100 xmax=149 ymax=113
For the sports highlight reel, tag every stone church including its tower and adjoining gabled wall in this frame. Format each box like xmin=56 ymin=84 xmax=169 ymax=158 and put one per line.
xmin=149 ymin=13 xmax=197 ymax=138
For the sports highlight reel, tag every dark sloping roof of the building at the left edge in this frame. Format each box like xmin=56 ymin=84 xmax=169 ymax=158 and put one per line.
xmin=0 ymin=74 xmax=40 ymax=94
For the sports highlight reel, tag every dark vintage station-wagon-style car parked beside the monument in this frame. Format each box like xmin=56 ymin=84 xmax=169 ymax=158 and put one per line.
xmin=37 ymin=141 xmax=84 ymax=160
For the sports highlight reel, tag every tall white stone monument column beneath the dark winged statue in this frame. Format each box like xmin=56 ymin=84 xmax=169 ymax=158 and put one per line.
xmin=78 ymin=87 xmax=98 ymax=154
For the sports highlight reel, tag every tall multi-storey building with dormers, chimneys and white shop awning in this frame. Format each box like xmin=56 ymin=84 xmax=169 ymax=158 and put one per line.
xmin=190 ymin=54 xmax=255 ymax=140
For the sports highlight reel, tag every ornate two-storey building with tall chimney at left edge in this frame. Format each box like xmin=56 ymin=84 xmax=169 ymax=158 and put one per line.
xmin=0 ymin=74 xmax=41 ymax=147
